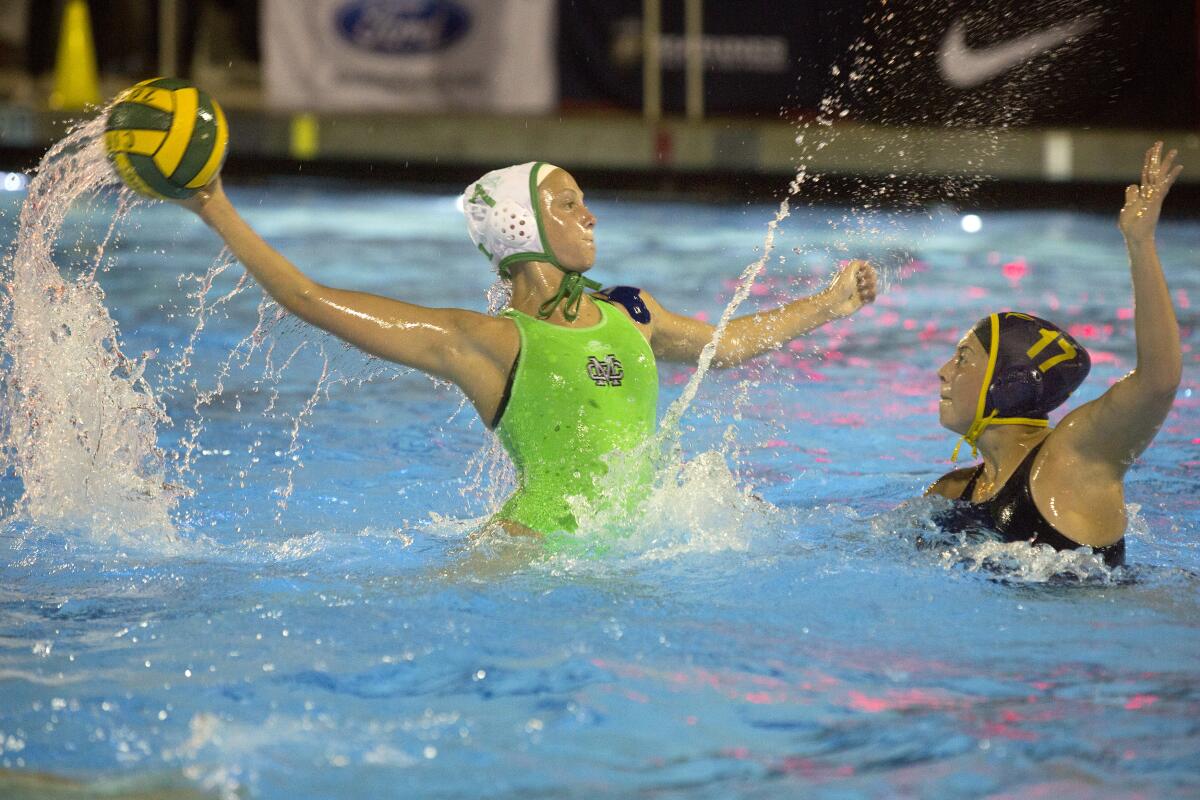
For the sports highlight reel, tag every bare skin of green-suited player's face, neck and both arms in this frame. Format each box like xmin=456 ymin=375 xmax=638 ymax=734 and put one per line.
xmin=180 ymin=169 xmax=876 ymax=537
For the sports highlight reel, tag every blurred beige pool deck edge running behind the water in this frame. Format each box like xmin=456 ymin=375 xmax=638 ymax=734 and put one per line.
xmin=0 ymin=103 xmax=1200 ymax=205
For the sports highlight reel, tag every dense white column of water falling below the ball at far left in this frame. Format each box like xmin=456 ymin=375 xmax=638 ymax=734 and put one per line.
xmin=0 ymin=114 xmax=178 ymax=533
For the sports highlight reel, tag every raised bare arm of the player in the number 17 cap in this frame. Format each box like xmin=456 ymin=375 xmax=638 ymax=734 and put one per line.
xmin=1056 ymin=142 xmax=1183 ymax=475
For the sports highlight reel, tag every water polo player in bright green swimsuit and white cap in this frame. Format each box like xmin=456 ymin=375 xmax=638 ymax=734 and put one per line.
xmin=182 ymin=162 xmax=876 ymax=534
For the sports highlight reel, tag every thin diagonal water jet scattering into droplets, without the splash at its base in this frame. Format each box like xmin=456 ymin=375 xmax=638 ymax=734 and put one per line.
xmin=633 ymin=0 xmax=1118 ymax=537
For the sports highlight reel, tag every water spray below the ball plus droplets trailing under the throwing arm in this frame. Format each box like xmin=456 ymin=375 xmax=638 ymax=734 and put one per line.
xmin=0 ymin=113 xmax=439 ymax=542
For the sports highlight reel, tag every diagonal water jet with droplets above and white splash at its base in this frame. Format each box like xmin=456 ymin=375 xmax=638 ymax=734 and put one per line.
xmin=552 ymin=0 xmax=1113 ymax=547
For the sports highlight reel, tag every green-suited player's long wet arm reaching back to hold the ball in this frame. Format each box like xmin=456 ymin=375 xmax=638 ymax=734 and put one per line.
xmin=181 ymin=179 xmax=508 ymax=385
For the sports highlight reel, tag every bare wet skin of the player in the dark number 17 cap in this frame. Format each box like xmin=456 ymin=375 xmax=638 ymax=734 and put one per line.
xmin=929 ymin=143 xmax=1182 ymax=547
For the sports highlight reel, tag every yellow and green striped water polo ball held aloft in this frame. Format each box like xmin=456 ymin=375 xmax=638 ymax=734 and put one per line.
xmin=104 ymin=78 xmax=229 ymax=200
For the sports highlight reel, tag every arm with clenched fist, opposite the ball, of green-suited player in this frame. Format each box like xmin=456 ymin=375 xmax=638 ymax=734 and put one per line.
xmin=642 ymin=261 xmax=876 ymax=367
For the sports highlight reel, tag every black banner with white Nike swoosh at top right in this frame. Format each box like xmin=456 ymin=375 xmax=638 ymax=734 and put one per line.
xmin=847 ymin=0 xmax=1196 ymax=127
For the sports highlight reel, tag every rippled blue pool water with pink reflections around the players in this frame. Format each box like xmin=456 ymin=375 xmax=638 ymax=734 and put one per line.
xmin=0 ymin=159 xmax=1200 ymax=800
